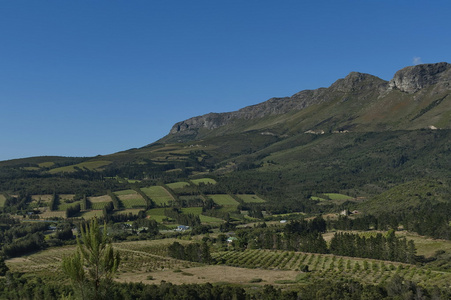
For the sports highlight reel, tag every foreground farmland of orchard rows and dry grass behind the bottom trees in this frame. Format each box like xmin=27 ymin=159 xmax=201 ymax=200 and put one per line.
xmin=5 ymin=238 xmax=451 ymax=287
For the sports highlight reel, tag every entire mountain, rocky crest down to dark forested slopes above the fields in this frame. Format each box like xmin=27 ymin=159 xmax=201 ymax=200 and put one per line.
xmin=0 ymin=63 xmax=451 ymax=212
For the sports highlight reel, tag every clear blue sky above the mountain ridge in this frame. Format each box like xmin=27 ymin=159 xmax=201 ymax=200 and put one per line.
xmin=0 ymin=0 xmax=451 ymax=160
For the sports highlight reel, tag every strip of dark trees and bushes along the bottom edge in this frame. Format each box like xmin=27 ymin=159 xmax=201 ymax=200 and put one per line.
xmin=0 ymin=273 xmax=451 ymax=300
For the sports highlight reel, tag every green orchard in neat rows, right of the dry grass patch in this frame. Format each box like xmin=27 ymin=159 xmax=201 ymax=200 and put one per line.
xmin=212 ymin=250 xmax=451 ymax=287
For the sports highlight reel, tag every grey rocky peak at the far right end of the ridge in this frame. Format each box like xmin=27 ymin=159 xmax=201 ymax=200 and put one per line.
xmin=388 ymin=62 xmax=451 ymax=94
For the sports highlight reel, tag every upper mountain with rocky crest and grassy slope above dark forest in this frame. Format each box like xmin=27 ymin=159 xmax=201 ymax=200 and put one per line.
xmin=160 ymin=63 xmax=451 ymax=142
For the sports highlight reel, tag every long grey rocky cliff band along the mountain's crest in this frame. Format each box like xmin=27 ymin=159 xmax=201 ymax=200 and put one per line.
xmin=170 ymin=62 xmax=451 ymax=137
